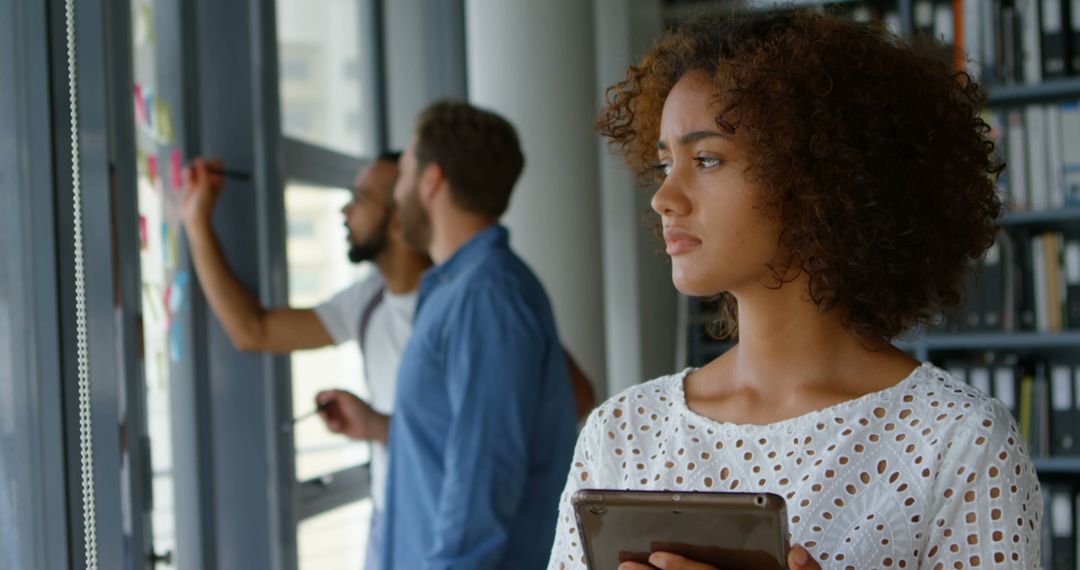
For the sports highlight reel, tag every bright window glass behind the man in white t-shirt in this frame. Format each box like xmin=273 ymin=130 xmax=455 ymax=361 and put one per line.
xmin=275 ymin=0 xmax=378 ymax=570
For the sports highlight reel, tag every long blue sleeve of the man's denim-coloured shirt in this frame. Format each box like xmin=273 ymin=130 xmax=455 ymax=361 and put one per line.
xmin=428 ymin=287 xmax=557 ymax=569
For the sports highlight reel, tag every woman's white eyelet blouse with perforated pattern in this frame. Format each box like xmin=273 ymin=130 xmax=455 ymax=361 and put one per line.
xmin=549 ymin=363 xmax=1042 ymax=570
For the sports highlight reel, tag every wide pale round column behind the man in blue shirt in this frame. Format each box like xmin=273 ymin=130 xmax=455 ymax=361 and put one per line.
xmin=465 ymin=0 xmax=607 ymax=394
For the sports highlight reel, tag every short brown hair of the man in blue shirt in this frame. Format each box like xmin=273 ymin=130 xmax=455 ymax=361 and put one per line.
xmin=415 ymin=100 xmax=525 ymax=219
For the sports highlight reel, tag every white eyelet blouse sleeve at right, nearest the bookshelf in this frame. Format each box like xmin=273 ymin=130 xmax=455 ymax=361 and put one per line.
xmin=919 ymin=403 xmax=1042 ymax=569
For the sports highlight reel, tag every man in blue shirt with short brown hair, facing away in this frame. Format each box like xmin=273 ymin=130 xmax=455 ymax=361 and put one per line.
xmin=381 ymin=101 xmax=576 ymax=569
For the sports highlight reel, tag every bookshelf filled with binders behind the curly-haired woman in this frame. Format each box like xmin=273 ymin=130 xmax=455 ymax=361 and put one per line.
xmin=666 ymin=0 xmax=1080 ymax=569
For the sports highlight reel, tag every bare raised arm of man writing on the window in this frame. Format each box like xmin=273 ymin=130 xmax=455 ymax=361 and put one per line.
xmin=180 ymin=159 xmax=334 ymax=353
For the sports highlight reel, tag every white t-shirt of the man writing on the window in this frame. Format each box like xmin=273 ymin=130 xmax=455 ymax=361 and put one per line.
xmin=314 ymin=272 xmax=417 ymax=510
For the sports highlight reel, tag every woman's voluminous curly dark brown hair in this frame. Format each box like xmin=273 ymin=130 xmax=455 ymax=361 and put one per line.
xmin=596 ymin=10 xmax=1003 ymax=340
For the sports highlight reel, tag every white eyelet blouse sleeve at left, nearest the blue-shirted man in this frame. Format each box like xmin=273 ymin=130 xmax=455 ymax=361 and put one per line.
xmin=548 ymin=408 xmax=604 ymax=570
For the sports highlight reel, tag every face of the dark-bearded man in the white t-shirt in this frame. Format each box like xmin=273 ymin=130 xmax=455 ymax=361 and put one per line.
xmin=341 ymin=161 xmax=397 ymax=263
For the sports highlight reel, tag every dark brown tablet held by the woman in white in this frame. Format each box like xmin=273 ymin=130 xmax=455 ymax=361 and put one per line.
xmin=571 ymin=489 xmax=787 ymax=570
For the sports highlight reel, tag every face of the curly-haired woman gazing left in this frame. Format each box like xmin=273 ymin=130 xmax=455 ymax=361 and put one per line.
xmin=652 ymin=72 xmax=780 ymax=296
